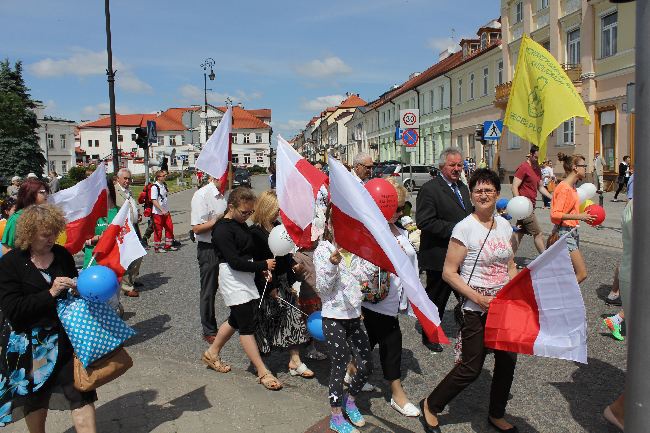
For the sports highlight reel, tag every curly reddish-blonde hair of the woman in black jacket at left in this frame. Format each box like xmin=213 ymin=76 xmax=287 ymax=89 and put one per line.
xmin=15 ymin=204 xmax=65 ymax=250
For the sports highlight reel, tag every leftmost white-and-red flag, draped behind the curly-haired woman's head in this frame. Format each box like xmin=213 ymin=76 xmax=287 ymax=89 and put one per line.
xmin=48 ymin=162 xmax=108 ymax=254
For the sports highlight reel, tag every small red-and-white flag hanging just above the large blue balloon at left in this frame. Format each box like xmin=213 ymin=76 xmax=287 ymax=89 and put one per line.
xmin=93 ymin=200 xmax=147 ymax=277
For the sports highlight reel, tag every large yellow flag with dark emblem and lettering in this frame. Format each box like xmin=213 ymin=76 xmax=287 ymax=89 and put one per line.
xmin=503 ymin=35 xmax=591 ymax=160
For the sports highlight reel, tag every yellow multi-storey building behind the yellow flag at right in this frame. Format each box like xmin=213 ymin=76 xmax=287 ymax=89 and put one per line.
xmin=494 ymin=0 xmax=635 ymax=179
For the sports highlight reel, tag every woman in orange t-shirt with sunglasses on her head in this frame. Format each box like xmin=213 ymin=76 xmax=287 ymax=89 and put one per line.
xmin=551 ymin=152 xmax=594 ymax=283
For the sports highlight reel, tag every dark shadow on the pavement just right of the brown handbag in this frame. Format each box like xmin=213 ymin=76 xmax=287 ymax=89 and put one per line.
xmin=65 ymin=386 xmax=212 ymax=433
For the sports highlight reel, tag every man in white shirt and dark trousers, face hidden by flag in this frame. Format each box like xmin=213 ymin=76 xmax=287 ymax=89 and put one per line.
xmin=190 ymin=176 xmax=227 ymax=344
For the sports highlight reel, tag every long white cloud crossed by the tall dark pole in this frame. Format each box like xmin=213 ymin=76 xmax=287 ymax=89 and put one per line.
xmin=29 ymin=48 xmax=153 ymax=93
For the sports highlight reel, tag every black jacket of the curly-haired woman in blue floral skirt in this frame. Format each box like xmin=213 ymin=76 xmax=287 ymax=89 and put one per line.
xmin=0 ymin=245 xmax=78 ymax=332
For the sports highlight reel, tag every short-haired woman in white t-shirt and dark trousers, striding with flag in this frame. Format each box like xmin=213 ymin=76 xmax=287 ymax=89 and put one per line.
xmin=420 ymin=168 xmax=518 ymax=433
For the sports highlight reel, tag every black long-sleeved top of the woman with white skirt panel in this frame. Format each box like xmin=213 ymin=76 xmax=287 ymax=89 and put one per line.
xmin=212 ymin=218 xmax=267 ymax=272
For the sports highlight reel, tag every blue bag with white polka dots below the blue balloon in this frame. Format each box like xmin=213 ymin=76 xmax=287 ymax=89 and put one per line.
xmin=56 ymin=296 xmax=135 ymax=368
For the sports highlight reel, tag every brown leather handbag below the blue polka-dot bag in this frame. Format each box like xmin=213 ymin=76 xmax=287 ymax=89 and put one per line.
xmin=74 ymin=347 xmax=133 ymax=392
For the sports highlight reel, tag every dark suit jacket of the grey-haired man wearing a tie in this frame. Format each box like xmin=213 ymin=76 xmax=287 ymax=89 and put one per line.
xmin=415 ymin=176 xmax=473 ymax=271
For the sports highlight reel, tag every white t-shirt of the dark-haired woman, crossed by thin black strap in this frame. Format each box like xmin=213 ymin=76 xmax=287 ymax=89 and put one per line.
xmin=451 ymin=214 xmax=514 ymax=311
